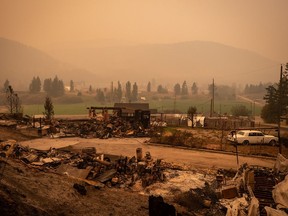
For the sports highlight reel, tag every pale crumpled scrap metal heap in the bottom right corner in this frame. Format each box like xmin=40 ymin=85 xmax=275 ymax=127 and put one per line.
xmin=216 ymin=154 xmax=288 ymax=216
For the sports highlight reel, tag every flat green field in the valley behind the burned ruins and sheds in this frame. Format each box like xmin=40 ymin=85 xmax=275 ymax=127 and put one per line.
xmin=23 ymin=97 xmax=261 ymax=115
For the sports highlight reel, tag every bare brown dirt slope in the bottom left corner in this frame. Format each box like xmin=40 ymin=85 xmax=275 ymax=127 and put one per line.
xmin=0 ymin=159 xmax=148 ymax=216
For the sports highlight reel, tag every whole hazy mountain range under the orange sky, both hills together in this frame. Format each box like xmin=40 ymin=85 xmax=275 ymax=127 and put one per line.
xmin=0 ymin=38 xmax=280 ymax=88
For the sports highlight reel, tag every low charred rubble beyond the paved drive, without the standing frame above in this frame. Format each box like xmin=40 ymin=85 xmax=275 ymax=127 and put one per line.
xmin=0 ymin=111 xmax=156 ymax=139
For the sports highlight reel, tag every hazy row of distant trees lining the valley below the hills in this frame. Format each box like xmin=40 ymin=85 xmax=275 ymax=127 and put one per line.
xmin=4 ymin=76 xmax=269 ymax=105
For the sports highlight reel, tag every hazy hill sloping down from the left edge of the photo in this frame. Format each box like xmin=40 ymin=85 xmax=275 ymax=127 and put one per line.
xmin=0 ymin=38 xmax=91 ymax=90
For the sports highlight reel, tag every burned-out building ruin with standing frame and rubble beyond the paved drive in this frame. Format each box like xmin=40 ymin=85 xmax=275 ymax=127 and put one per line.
xmin=0 ymin=103 xmax=155 ymax=139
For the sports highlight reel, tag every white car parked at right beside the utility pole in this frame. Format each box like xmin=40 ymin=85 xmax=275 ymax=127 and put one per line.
xmin=227 ymin=130 xmax=278 ymax=146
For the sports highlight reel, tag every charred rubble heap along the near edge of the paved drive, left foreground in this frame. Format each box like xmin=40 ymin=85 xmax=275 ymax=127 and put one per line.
xmin=0 ymin=140 xmax=164 ymax=191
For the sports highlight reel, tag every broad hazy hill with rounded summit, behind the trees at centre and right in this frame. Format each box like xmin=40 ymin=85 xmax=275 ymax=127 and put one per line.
xmin=53 ymin=41 xmax=280 ymax=84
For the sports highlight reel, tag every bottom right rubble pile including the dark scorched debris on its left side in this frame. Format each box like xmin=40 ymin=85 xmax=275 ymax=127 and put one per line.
xmin=169 ymin=154 xmax=288 ymax=216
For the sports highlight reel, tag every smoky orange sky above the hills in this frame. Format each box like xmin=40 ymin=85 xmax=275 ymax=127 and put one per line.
xmin=0 ymin=0 xmax=288 ymax=63
